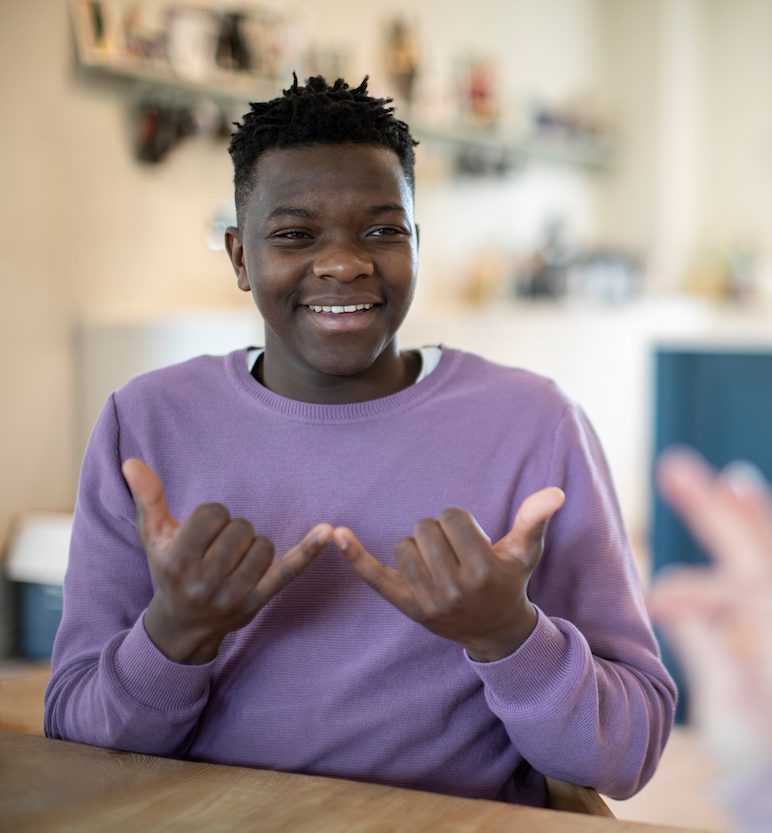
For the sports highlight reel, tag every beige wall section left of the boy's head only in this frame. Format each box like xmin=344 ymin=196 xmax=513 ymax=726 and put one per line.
xmin=0 ymin=0 xmax=248 ymax=535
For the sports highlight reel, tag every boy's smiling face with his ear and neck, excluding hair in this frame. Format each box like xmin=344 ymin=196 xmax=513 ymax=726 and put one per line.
xmin=226 ymin=144 xmax=418 ymax=401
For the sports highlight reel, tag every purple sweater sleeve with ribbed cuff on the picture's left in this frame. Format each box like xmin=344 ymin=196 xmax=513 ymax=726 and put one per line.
xmin=45 ymin=397 xmax=211 ymax=755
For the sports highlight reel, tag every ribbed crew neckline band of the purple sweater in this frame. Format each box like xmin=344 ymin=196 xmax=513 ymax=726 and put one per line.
xmin=226 ymin=347 xmax=461 ymax=423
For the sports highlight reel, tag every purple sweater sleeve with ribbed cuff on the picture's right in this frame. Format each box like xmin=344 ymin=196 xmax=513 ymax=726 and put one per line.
xmin=468 ymin=406 xmax=676 ymax=798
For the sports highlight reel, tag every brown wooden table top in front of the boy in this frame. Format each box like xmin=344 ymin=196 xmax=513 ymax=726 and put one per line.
xmin=0 ymin=731 xmax=712 ymax=833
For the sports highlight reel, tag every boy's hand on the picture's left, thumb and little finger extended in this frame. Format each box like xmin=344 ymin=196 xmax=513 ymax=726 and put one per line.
xmin=122 ymin=459 xmax=332 ymax=664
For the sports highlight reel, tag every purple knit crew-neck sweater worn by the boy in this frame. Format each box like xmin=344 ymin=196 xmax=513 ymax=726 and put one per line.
xmin=45 ymin=348 xmax=675 ymax=803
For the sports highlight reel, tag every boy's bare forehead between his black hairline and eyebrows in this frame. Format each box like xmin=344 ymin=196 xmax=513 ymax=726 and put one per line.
xmin=246 ymin=144 xmax=413 ymax=218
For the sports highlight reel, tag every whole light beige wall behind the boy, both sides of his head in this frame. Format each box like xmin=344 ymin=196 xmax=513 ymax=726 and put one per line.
xmin=7 ymin=0 xmax=772 ymax=560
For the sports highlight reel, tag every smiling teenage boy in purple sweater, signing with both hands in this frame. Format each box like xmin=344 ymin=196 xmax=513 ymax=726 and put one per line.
xmin=46 ymin=77 xmax=675 ymax=804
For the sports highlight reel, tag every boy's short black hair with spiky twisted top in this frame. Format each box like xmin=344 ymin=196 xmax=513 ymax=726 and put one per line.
xmin=228 ymin=73 xmax=418 ymax=224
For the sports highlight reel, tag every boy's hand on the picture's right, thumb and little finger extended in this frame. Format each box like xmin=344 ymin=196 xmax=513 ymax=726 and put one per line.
xmin=335 ymin=486 xmax=565 ymax=662
